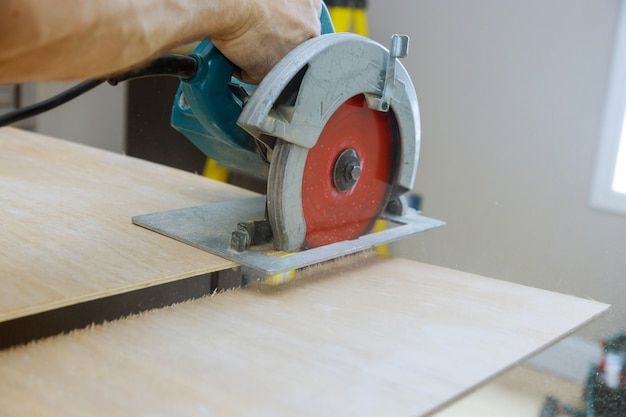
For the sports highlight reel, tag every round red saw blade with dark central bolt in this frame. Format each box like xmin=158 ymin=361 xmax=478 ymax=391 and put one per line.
xmin=302 ymin=95 xmax=399 ymax=248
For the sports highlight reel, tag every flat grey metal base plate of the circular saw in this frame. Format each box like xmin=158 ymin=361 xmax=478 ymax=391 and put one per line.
xmin=132 ymin=196 xmax=445 ymax=277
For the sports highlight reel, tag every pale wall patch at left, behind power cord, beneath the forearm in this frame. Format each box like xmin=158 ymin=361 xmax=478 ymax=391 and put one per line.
xmin=35 ymin=82 xmax=126 ymax=152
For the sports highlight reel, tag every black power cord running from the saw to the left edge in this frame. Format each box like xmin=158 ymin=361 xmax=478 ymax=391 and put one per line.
xmin=0 ymin=54 xmax=198 ymax=127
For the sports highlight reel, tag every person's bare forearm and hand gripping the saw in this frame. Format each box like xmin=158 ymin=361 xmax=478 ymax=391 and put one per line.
xmin=0 ymin=0 xmax=321 ymax=83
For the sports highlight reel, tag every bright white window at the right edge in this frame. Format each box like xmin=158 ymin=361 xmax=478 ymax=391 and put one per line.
xmin=591 ymin=3 xmax=626 ymax=214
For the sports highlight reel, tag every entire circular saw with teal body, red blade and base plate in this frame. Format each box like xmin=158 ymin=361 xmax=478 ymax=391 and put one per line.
xmin=133 ymin=5 xmax=444 ymax=277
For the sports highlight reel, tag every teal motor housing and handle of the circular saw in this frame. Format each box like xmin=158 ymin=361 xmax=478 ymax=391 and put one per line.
xmin=171 ymin=5 xmax=334 ymax=178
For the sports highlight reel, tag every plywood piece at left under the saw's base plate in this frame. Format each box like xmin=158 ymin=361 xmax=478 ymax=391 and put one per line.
xmin=0 ymin=128 xmax=247 ymax=322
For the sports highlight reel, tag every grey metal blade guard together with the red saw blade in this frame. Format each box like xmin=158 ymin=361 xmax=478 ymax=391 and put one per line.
xmin=238 ymin=33 xmax=420 ymax=251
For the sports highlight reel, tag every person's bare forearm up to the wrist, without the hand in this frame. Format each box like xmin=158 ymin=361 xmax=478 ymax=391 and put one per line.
xmin=0 ymin=0 xmax=246 ymax=83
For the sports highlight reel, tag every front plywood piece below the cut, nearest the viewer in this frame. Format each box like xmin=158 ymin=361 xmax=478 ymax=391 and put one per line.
xmin=0 ymin=259 xmax=607 ymax=417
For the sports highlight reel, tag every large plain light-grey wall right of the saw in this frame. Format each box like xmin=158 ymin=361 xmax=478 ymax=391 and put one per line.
xmin=369 ymin=0 xmax=626 ymax=337
